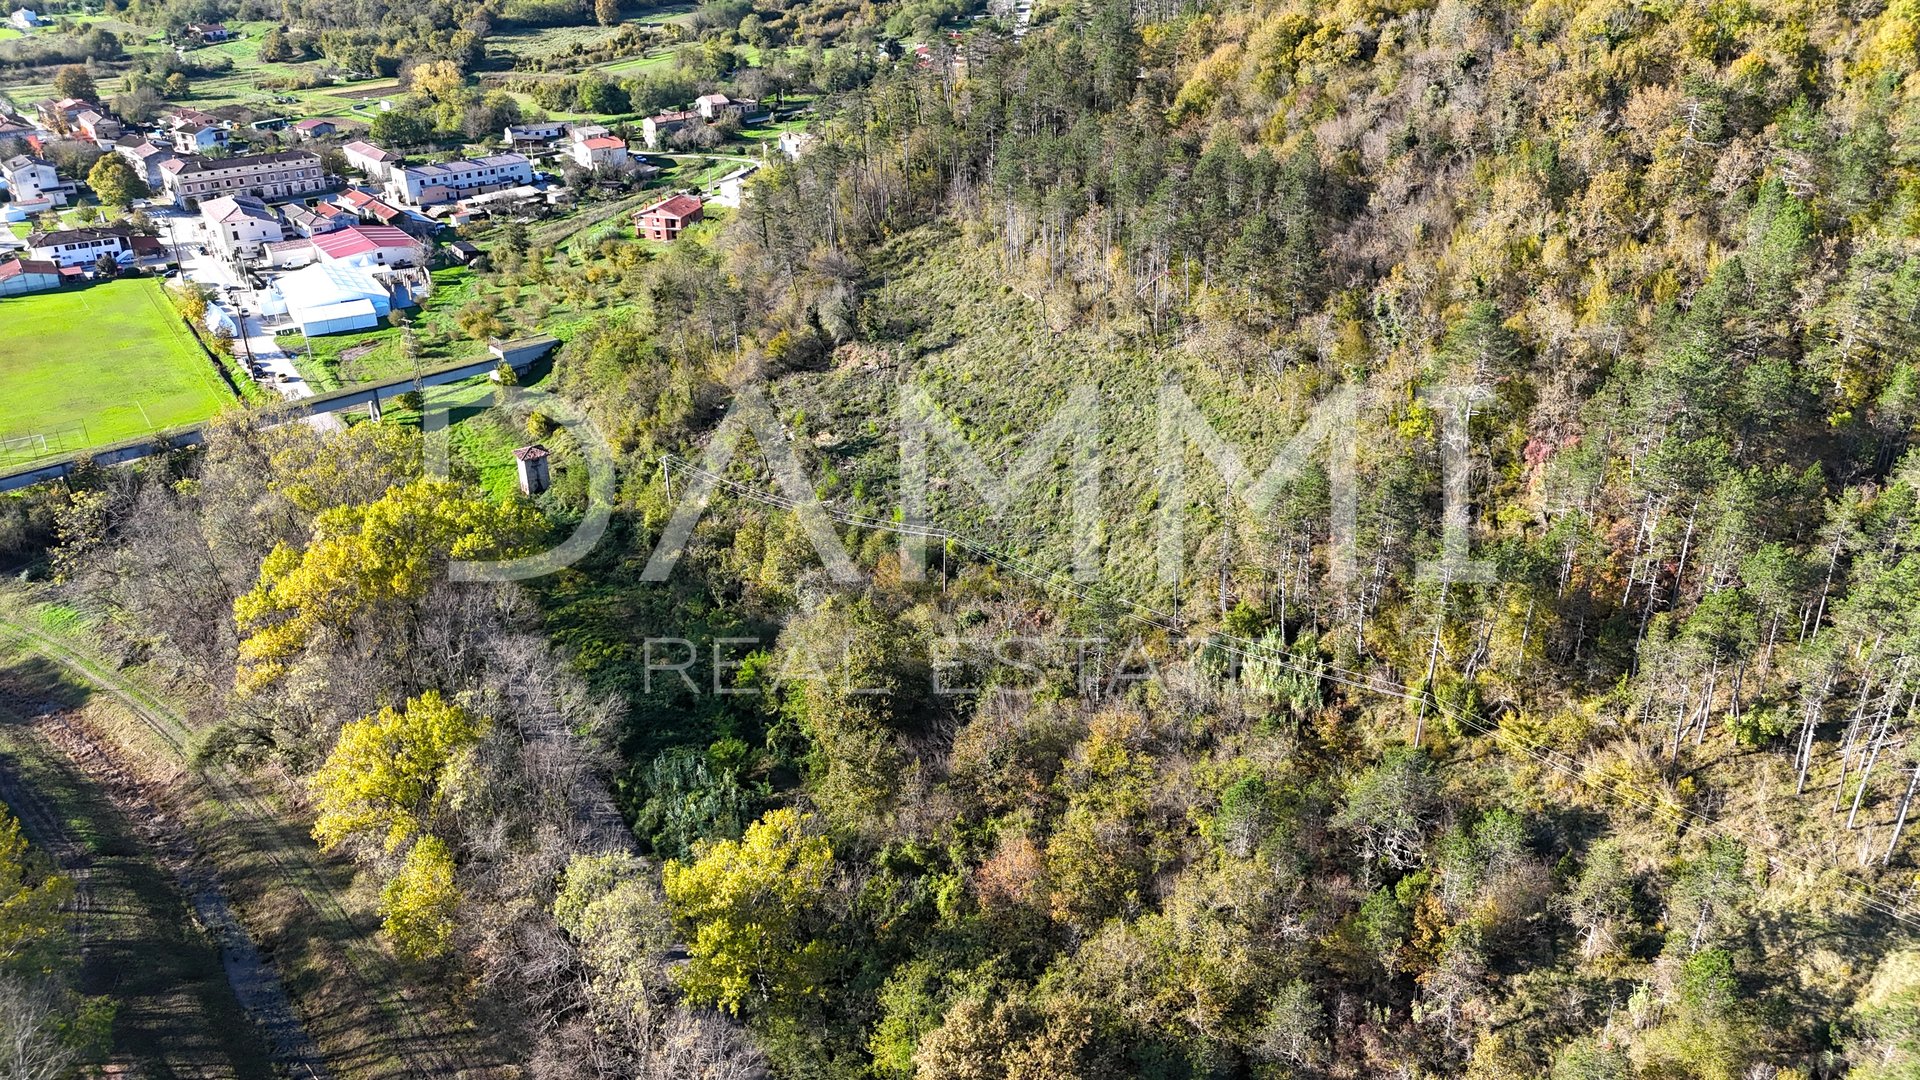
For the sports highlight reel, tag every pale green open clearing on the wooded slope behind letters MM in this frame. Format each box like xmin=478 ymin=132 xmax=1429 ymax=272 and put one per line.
xmin=776 ymin=229 xmax=1313 ymax=592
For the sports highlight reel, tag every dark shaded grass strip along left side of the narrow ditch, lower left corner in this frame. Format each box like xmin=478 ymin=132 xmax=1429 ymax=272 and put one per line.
xmin=0 ymin=642 xmax=273 ymax=1078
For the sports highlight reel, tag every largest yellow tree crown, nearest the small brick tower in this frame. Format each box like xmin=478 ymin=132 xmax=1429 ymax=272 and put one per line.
xmin=234 ymin=477 xmax=545 ymax=692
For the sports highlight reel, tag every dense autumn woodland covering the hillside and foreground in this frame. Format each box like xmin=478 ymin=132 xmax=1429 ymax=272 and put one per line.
xmin=18 ymin=0 xmax=1920 ymax=1080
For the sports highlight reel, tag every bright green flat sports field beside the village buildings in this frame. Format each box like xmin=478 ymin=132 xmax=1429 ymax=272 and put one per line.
xmin=0 ymin=279 xmax=234 ymax=455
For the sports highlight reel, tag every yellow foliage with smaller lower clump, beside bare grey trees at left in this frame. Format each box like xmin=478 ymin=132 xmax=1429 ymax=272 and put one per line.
xmin=313 ymin=690 xmax=490 ymax=959
